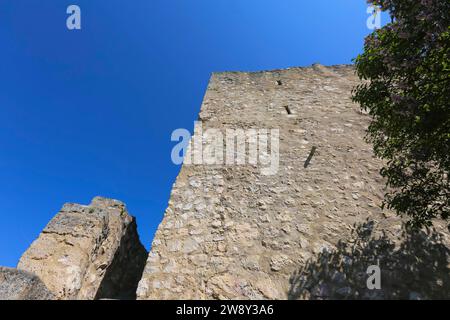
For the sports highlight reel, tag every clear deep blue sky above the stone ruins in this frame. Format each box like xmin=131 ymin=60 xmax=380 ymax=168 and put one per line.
xmin=0 ymin=0 xmax=386 ymax=266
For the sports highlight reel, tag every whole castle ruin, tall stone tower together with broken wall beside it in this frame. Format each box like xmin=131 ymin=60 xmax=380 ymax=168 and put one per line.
xmin=0 ymin=65 xmax=450 ymax=299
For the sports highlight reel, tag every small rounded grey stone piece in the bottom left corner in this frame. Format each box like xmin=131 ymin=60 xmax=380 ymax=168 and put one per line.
xmin=0 ymin=267 xmax=55 ymax=300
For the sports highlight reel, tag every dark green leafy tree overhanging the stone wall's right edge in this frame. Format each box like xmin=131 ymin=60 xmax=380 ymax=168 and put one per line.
xmin=353 ymin=0 xmax=450 ymax=229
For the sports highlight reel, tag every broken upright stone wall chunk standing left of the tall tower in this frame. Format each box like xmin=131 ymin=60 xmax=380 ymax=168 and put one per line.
xmin=18 ymin=197 xmax=147 ymax=299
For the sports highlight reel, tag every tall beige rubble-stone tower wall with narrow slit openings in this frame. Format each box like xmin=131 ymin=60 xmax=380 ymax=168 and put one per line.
xmin=137 ymin=65 xmax=450 ymax=299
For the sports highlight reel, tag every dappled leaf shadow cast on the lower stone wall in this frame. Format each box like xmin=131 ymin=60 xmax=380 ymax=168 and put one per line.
xmin=288 ymin=220 xmax=450 ymax=299
